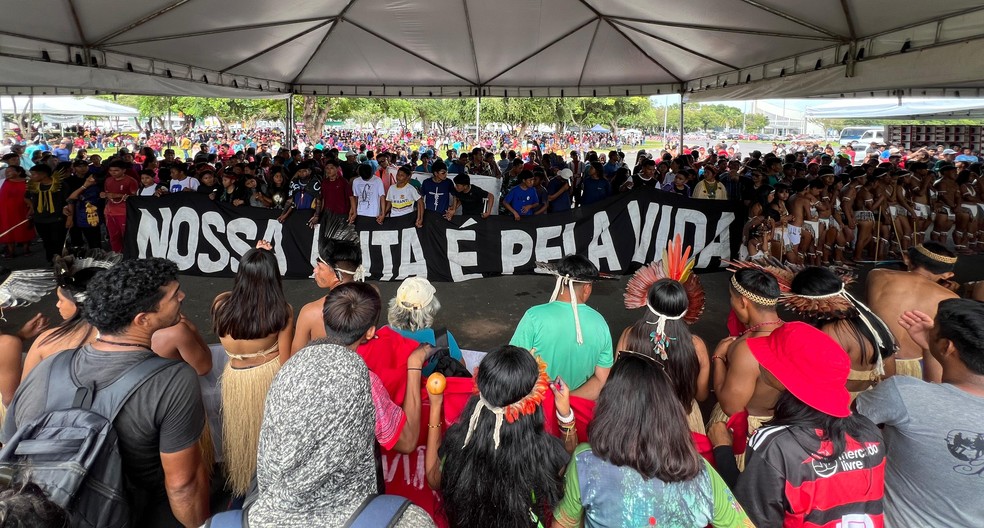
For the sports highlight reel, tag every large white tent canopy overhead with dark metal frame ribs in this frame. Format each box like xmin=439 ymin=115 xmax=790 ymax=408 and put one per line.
xmin=0 ymin=0 xmax=984 ymax=100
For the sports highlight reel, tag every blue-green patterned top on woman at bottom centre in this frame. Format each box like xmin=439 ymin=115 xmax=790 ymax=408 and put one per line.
xmin=554 ymin=444 xmax=754 ymax=528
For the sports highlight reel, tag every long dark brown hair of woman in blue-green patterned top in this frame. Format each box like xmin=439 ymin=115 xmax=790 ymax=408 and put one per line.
xmin=588 ymin=352 xmax=704 ymax=482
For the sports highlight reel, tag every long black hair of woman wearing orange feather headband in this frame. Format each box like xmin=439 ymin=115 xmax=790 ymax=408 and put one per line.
xmin=440 ymin=346 xmax=570 ymax=528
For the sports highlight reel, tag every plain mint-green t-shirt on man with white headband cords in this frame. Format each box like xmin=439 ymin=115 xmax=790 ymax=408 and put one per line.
xmin=509 ymin=301 xmax=614 ymax=390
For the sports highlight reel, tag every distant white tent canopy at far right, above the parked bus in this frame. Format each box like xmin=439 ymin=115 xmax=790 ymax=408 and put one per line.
xmin=806 ymin=98 xmax=984 ymax=120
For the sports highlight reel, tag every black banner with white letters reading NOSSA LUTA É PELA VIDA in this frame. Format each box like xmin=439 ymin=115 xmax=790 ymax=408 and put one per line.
xmin=125 ymin=190 xmax=742 ymax=281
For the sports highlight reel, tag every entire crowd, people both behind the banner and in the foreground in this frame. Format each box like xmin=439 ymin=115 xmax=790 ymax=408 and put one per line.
xmin=0 ymin=126 xmax=984 ymax=528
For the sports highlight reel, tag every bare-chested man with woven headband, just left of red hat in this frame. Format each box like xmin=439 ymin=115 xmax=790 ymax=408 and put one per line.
xmin=710 ymin=269 xmax=783 ymax=467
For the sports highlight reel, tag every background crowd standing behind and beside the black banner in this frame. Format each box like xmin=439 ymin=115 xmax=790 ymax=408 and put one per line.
xmin=0 ymin=125 xmax=984 ymax=265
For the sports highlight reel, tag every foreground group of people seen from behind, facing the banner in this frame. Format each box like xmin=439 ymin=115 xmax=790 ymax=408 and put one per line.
xmin=0 ymin=216 xmax=972 ymax=528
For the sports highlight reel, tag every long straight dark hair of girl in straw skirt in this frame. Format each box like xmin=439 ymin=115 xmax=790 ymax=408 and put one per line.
xmin=212 ymin=249 xmax=291 ymax=339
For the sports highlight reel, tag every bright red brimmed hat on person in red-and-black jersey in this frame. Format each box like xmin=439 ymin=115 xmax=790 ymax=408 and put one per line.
xmin=748 ymin=322 xmax=851 ymax=418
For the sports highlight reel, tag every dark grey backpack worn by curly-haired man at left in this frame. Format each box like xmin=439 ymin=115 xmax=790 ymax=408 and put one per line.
xmin=0 ymin=349 xmax=175 ymax=528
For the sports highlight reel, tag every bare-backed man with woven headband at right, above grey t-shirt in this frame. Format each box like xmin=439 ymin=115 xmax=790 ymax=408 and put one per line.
xmin=867 ymin=242 xmax=957 ymax=383
